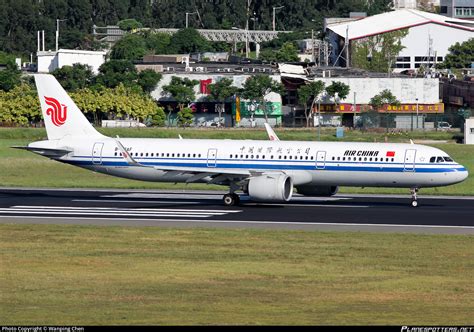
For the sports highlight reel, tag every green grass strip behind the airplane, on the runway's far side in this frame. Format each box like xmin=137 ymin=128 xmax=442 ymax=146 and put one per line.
xmin=0 ymin=128 xmax=474 ymax=195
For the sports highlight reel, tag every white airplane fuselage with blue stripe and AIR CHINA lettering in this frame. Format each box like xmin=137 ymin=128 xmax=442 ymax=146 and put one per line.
xmin=30 ymin=137 xmax=468 ymax=188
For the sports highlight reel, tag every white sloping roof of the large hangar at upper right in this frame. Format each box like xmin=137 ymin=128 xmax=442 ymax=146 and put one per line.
xmin=327 ymin=9 xmax=474 ymax=40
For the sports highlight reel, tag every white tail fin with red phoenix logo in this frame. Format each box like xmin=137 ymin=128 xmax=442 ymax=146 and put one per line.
xmin=35 ymin=74 xmax=102 ymax=140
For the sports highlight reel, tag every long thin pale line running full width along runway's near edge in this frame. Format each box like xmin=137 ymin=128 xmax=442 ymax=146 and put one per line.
xmin=0 ymin=215 xmax=474 ymax=230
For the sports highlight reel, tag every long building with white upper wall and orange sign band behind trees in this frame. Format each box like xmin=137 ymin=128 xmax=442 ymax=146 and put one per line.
xmin=281 ymin=67 xmax=444 ymax=130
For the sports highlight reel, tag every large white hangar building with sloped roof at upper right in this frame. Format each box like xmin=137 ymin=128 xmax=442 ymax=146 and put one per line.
xmin=326 ymin=9 xmax=474 ymax=72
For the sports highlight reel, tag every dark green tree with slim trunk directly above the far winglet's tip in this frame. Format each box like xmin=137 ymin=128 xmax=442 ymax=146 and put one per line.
xmin=242 ymin=75 xmax=284 ymax=122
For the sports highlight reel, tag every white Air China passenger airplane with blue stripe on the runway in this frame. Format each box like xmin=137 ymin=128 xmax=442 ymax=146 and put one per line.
xmin=16 ymin=74 xmax=468 ymax=207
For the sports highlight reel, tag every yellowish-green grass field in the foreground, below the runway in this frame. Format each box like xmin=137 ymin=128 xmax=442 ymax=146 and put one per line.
xmin=0 ymin=225 xmax=474 ymax=325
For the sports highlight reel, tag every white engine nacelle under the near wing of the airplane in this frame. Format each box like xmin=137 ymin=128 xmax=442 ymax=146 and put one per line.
xmin=248 ymin=174 xmax=293 ymax=202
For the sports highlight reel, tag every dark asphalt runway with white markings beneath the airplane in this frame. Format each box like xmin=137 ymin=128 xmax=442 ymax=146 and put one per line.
xmin=0 ymin=188 xmax=474 ymax=234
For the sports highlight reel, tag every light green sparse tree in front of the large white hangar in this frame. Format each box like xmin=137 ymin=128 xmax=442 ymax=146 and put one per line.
xmin=351 ymin=29 xmax=408 ymax=73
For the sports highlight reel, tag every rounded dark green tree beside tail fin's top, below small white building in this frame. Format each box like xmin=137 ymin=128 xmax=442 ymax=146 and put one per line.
xmin=52 ymin=63 xmax=95 ymax=91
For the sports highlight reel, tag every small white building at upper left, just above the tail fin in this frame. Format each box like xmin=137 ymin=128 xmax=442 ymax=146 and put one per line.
xmin=37 ymin=49 xmax=106 ymax=74
